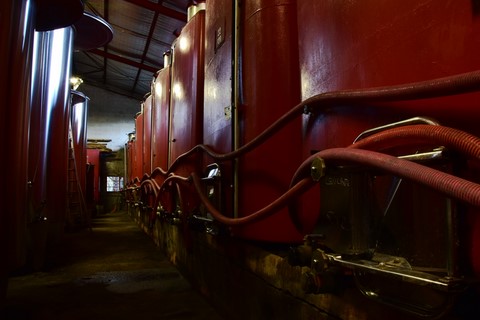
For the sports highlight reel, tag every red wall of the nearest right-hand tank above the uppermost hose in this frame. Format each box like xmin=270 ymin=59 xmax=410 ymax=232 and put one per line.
xmin=298 ymin=0 xmax=480 ymax=118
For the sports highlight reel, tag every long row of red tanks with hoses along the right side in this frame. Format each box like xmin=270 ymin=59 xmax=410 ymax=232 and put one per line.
xmin=126 ymin=0 xmax=480 ymax=317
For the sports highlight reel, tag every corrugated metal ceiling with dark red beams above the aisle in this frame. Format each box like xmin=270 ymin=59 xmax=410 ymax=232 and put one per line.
xmin=73 ymin=0 xmax=191 ymax=99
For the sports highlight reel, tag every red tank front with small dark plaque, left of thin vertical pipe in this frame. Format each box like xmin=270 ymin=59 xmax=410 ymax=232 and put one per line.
xmin=203 ymin=0 xmax=235 ymax=219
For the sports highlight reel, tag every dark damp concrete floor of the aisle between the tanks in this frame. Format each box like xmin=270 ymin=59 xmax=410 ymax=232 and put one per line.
xmin=2 ymin=212 xmax=222 ymax=320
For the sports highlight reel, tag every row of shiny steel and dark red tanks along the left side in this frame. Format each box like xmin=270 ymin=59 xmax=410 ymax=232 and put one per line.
xmin=0 ymin=0 xmax=112 ymax=304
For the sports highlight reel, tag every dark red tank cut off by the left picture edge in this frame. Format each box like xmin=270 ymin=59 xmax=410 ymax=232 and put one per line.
xmin=0 ymin=1 xmax=34 ymax=302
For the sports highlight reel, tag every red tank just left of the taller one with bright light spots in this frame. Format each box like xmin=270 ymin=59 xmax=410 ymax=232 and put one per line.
xmin=152 ymin=66 xmax=170 ymax=171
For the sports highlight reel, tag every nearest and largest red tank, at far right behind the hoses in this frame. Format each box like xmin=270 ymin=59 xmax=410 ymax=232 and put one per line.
xmin=293 ymin=0 xmax=480 ymax=315
